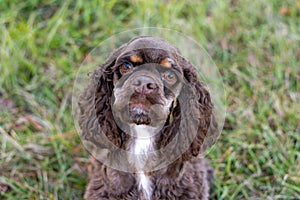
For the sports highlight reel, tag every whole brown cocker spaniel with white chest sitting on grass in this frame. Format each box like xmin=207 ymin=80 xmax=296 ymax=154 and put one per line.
xmin=79 ymin=36 xmax=216 ymax=200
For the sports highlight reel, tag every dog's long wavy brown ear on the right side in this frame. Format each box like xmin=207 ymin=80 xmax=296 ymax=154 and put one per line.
xmin=157 ymin=57 xmax=216 ymax=160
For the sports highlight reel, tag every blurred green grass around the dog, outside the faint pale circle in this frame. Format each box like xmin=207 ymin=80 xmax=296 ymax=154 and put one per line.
xmin=0 ymin=0 xmax=300 ymax=199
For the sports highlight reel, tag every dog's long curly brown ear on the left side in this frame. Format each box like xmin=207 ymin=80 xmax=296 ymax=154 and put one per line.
xmin=79 ymin=45 xmax=125 ymax=148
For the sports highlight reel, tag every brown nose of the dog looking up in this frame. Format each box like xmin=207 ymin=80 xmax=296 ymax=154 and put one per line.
xmin=133 ymin=76 xmax=158 ymax=94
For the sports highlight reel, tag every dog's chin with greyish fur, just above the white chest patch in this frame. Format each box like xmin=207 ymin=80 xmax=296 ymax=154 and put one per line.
xmin=129 ymin=106 xmax=151 ymax=125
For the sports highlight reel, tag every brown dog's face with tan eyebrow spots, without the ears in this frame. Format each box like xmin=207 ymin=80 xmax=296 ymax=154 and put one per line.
xmin=112 ymin=48 xmax=183 ymax=127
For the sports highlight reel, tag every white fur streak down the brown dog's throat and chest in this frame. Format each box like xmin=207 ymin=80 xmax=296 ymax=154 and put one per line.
xmin=129 ymin=125 xmax=156 ymax=200
